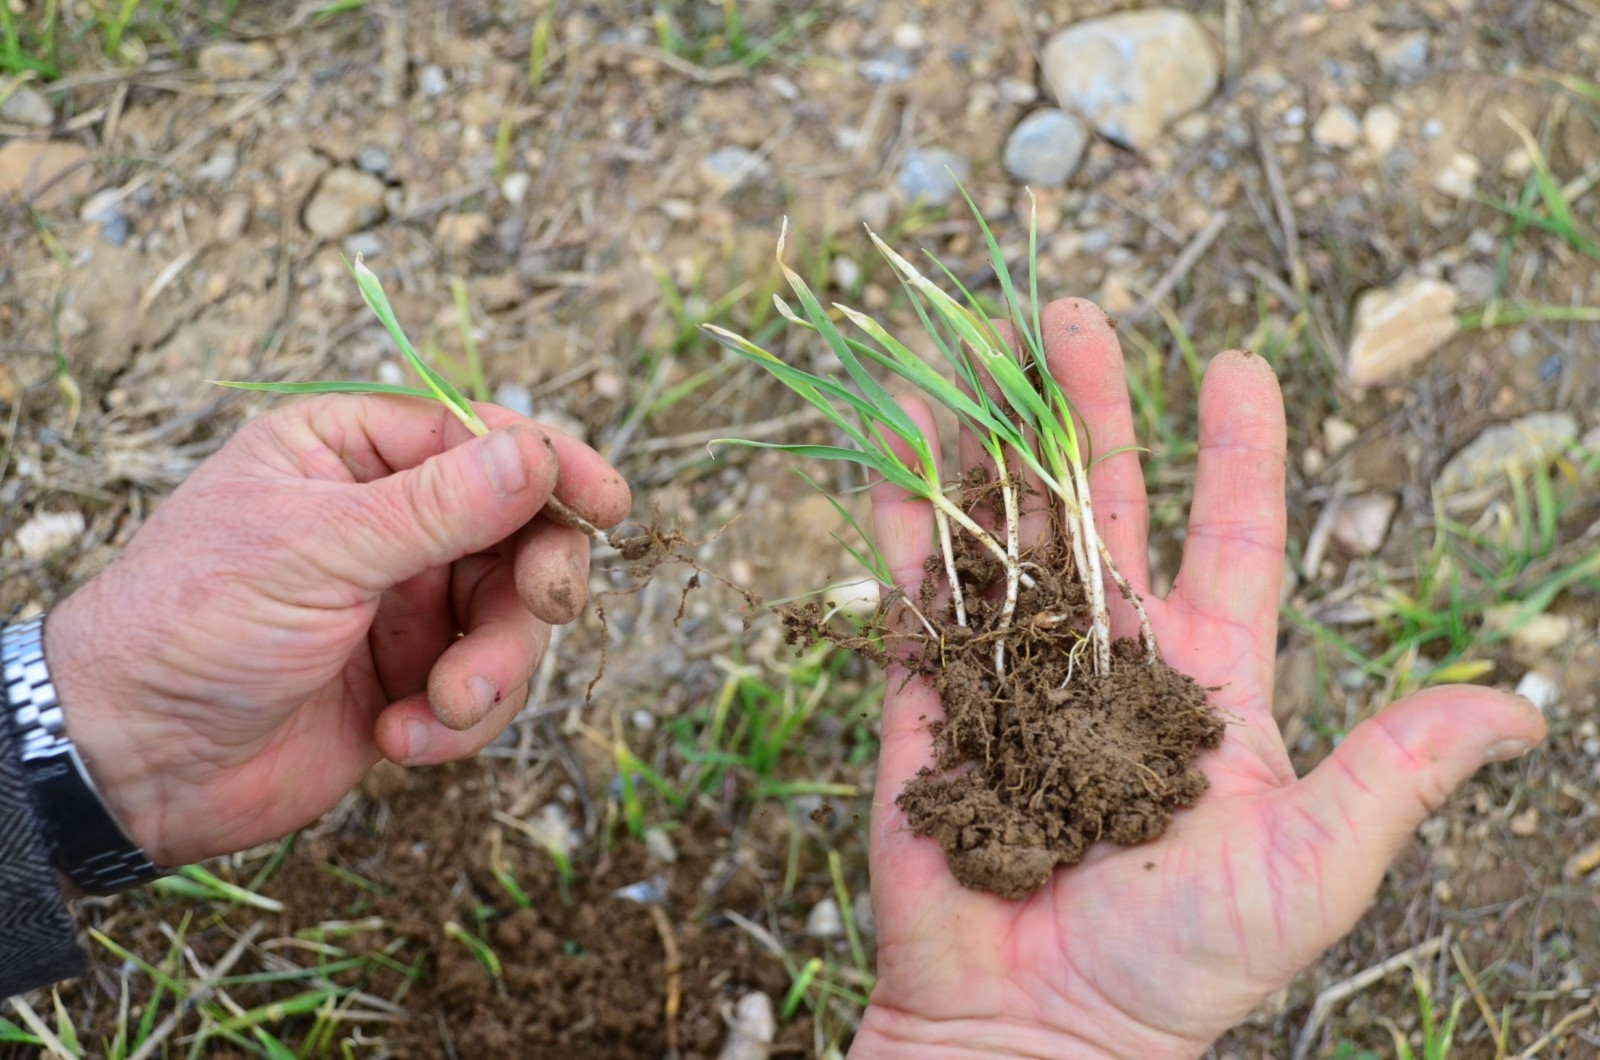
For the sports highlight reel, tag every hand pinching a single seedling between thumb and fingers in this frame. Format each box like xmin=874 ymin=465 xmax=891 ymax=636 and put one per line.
xmin=45 ymin=397 xmax=629 ymax=865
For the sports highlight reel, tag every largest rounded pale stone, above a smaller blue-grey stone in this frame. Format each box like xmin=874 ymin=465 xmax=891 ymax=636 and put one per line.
xmin=1042 ymin=8 xmax=1221 ymax=151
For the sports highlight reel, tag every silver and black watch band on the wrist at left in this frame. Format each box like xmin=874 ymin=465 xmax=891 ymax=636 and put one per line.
xmin=0 ymin=615 xmax=166 ymax=895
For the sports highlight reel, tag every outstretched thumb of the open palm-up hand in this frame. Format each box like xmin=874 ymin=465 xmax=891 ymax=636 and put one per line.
xmin=1282 ymin=685 xmax=1546 ymax=934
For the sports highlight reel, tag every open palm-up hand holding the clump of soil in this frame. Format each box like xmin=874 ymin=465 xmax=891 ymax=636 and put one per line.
xmin=854 ymin=301 xmax=1544 ymax=1058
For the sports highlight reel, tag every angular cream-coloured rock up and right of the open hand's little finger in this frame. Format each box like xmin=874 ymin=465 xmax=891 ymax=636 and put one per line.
xmin=1347 ymin=277 xmax=1461 ymax=386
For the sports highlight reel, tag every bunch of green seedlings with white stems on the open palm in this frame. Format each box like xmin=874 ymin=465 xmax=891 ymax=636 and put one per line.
xmin=706 ymin=192 xmax=1158 ymax=677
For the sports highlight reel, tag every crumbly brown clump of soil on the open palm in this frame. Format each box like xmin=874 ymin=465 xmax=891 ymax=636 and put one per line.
xmin=786 ymin=512 xmax=1222 ymax=898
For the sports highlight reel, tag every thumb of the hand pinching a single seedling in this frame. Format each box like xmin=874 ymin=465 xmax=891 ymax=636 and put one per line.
xmin=339 ymin=426 xmax=560 ymax=592
